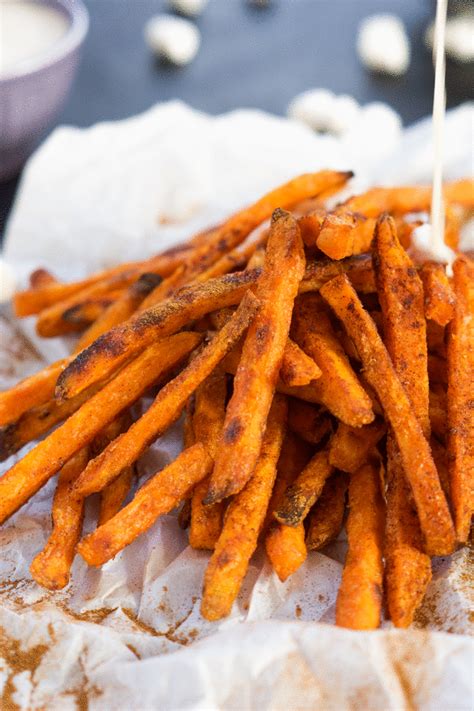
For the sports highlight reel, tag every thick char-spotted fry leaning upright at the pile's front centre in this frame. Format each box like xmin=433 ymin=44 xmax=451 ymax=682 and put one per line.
xmin=204 ymin=210 xmax=305 ymax=504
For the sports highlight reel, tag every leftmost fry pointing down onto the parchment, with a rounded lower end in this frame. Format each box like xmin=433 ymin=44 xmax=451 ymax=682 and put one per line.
xmin=30 ymin=446 xmax=89 ymax=590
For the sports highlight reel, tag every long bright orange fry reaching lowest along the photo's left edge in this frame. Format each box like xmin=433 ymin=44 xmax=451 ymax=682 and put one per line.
xmin=0 ymin=333 xmax=200 ymax=523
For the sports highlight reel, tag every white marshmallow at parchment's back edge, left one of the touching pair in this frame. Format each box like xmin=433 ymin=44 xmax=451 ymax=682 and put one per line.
xmin=287 ymin=89 xmax=360 ymax=136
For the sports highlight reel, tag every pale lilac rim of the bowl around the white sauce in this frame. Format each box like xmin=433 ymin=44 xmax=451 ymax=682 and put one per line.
xmin=0 ymin=0 xmax=89 ymax=84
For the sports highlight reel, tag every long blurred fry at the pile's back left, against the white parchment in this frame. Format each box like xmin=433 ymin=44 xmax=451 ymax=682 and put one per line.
xmin=13 ymin=246 xmax=190 ymax=318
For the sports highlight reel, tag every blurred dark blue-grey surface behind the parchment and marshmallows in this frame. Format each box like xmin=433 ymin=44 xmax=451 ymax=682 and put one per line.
xmin=0 ymin=0 xmax=472 ymax=229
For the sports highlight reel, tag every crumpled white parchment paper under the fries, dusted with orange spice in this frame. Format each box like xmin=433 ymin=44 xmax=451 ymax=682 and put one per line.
xmin=0 ymin=102 xmax=474 ymax=711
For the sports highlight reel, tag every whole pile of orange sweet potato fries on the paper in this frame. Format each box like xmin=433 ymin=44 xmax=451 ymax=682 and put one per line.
xmin=0 ymin=170 xmax=474 ymax=629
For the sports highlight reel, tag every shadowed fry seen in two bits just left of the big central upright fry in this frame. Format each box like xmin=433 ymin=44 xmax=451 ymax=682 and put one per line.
xmin=189 ymin=368 xmax=227 ymax=550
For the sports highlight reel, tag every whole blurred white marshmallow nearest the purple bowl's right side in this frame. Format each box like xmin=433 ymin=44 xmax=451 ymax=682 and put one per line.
xmin=145 ymin=15 xmax=201 ymax=66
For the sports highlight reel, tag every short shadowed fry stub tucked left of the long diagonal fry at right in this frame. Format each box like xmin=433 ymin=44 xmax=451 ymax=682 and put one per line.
xmin=329 ymin=422 xmax=385 ymax=474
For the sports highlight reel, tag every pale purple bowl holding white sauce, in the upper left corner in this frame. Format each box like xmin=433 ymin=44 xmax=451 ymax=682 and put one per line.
xmin=0 ymin=0 xmax=89 ymax=180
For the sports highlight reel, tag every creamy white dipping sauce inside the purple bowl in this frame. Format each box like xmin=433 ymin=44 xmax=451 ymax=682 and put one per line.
xmin=0 ymin=0 xmax=70 ymax=75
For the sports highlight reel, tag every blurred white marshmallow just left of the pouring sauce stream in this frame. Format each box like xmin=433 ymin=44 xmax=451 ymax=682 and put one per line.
xmin=356 ymin=13 xmax=410 ymax=76
